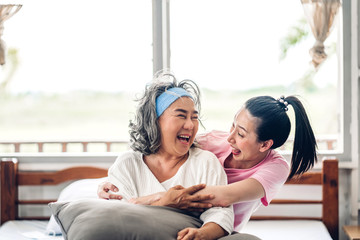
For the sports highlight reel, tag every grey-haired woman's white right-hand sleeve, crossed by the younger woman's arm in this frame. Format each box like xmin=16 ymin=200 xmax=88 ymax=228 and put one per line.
xmin=195 ymin=154 xmax=234 ymax=235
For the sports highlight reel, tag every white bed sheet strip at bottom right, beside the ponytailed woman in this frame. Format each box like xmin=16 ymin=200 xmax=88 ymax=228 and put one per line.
xmin=241 ymin=220 xmax=332 ymax=240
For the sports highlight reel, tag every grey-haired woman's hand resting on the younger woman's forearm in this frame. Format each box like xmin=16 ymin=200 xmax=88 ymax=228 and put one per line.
xmin=151 ymin=184 xmax=214 ymax=211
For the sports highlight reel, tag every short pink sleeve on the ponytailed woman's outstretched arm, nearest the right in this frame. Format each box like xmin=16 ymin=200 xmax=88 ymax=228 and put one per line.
xmin=251 ymin=160 xmax=289 ymax=206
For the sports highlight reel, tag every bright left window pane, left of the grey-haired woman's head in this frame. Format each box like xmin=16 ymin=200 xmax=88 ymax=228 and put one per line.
xmin=0 ymin=0 xmax=152 ymax=148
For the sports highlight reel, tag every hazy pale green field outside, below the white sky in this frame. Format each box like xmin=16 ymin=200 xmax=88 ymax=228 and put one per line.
xmin=0 ymin=87 xmax=338 ymax=145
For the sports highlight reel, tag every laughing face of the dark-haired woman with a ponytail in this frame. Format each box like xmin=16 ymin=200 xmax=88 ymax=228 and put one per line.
xmin=228 ymin=108 xmax=269 ymax=168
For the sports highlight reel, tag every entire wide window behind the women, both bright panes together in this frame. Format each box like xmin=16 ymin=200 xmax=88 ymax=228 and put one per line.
xmin=0 ymin=0 xmax=341 ymax=152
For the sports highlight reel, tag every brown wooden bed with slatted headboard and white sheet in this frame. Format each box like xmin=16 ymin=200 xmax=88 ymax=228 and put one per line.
xmin=0 ymin=159 xmax=339 ymax=240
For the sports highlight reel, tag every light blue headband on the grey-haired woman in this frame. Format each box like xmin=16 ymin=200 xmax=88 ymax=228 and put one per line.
xmin=156 ymin=87 xmax=193 ymax=117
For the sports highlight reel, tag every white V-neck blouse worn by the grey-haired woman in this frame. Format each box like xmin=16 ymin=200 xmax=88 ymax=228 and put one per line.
xmin=108 ymin=148 xmax=234 ymax=234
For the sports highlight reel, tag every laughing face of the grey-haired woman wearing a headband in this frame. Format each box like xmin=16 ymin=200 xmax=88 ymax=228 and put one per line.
xmin=159 ymin=97 xmax=199 ymax=157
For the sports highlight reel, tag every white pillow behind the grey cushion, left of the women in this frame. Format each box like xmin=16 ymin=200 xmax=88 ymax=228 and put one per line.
xmin=46 ymin=177 xmax=107 ymax=235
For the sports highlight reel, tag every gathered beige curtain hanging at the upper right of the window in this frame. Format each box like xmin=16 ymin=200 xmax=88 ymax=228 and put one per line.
xmin=301 ymin=0 xmax=341 ymax=68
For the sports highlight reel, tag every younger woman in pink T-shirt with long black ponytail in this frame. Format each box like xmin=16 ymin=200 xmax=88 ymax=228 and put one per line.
xmin=190 ymin=96 xmax=317 ymax=231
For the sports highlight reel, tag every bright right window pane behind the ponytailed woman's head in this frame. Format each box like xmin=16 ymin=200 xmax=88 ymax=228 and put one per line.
xmin=170 ymin=0 xmax=340 ymax=150
